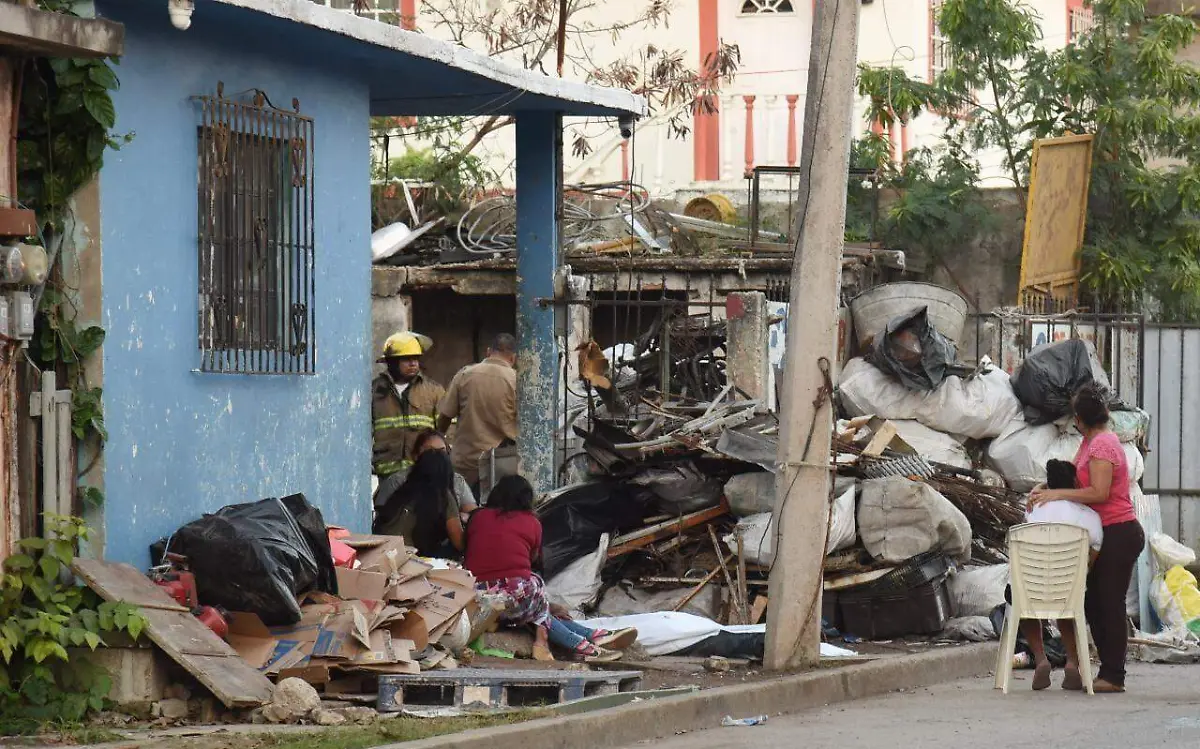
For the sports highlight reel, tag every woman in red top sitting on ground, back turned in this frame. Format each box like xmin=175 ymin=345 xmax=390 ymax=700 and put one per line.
xmin=463 ymin=475 xmax=637 ymax=661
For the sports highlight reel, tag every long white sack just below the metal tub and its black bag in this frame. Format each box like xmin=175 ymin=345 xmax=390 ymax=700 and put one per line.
xmin=838 ymin=359 xmax=1021 ymax=439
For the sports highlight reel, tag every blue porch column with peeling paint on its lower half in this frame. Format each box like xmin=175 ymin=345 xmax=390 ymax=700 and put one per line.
xmin=516 ymin=112 xmax=563 ymax=492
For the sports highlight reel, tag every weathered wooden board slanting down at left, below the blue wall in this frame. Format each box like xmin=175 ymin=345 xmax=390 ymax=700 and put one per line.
xmin=71 ymin=559 xmax=275 ymax=708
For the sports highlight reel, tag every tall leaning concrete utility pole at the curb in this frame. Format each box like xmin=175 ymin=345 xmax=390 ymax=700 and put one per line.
xmin=766 ymin=0 xmax=859 ymax=670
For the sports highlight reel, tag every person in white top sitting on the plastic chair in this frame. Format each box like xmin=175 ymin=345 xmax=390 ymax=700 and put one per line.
xmin=1004 ymin=460 xmax=1104 ymax=690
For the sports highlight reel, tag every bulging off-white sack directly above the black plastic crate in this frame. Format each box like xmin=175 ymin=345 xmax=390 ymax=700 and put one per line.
xmin=858 ymin=477 xmax=971 ymax=564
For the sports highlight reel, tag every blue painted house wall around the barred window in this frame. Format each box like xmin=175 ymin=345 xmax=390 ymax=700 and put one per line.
xmin=98 ymin=1 xmax=371 ymax=567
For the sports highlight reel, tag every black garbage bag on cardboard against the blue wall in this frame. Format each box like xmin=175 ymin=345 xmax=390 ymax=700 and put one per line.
xmin=150 ymin=495 xmax=337 ymax=627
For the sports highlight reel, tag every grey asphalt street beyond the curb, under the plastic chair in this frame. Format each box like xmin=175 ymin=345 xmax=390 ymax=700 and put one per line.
xmin=629 ymin=664 xmax=1200 ymax=749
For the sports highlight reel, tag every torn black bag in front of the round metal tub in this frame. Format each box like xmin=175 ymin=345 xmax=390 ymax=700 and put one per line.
xmin=866 ymin=307 xmax=958 ymax=390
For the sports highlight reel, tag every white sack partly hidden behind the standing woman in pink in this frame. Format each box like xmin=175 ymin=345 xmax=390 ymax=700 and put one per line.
xmin=988 ymin=419 xmax=1146 ymax=492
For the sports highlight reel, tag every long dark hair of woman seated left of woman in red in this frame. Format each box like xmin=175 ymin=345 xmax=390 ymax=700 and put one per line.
xmin=372 ymin=444 xmax=454 ymax=557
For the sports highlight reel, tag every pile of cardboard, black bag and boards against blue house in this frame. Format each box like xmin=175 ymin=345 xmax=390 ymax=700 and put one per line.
xmin=74 ymin=495 xmax=487 ymax=709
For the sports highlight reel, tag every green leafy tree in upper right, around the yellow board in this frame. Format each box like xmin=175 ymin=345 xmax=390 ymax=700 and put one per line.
xmin=859 ymin=0 xmax=1200 ymax=319
